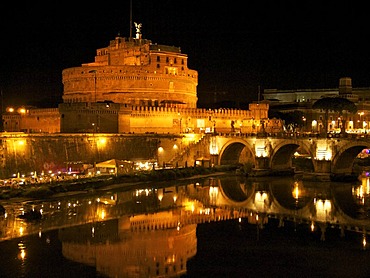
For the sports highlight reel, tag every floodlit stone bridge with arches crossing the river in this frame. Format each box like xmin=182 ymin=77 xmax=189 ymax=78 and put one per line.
xmin=205 ymin=133 xmax=370 ymax=179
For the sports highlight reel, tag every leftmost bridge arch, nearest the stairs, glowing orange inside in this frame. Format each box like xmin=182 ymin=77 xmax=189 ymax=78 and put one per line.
xmin=218 ymin=138 xmax=255 ymax=165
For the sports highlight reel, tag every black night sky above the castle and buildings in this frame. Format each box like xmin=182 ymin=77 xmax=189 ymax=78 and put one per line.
xmin=0 ymin=0 xmax=370 ymax=107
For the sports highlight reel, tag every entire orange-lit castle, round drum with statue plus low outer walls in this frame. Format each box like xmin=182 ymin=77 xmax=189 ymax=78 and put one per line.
xmin=3 ymin=24 xmax=282 ymax=134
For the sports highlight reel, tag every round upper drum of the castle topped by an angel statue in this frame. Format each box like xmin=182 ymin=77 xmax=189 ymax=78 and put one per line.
xmin=62 ymin=23 xmax=198 ymax=108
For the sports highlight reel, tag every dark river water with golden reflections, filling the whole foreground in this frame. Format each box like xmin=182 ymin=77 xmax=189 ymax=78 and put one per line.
xmin=0 ymin=177 xmax=370 ymax=277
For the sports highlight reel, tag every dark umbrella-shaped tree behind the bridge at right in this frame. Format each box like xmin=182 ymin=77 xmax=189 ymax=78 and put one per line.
xmin=312 ymin=97 xmax=357 ymax=134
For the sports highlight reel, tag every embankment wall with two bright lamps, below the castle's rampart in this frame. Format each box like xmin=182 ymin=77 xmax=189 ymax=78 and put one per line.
xmin=0 ymin=133 xmax=166 ymax=178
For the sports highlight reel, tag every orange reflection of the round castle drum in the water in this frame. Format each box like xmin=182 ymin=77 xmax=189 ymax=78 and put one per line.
xmin=59 ymin=218 xmax=197 ymax=277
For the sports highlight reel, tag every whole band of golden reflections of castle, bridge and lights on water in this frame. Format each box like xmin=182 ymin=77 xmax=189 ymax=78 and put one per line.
xmin=0 ymin=176 xmax=370 ymax=277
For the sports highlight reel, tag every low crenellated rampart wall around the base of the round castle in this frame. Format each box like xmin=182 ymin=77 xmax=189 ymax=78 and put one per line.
xmin=3 ymin=102 xmax=282 ymax=134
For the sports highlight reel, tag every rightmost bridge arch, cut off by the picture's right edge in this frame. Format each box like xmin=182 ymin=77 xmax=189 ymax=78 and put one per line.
xmin=331 ymin=140 xmax=370 ymax=174
